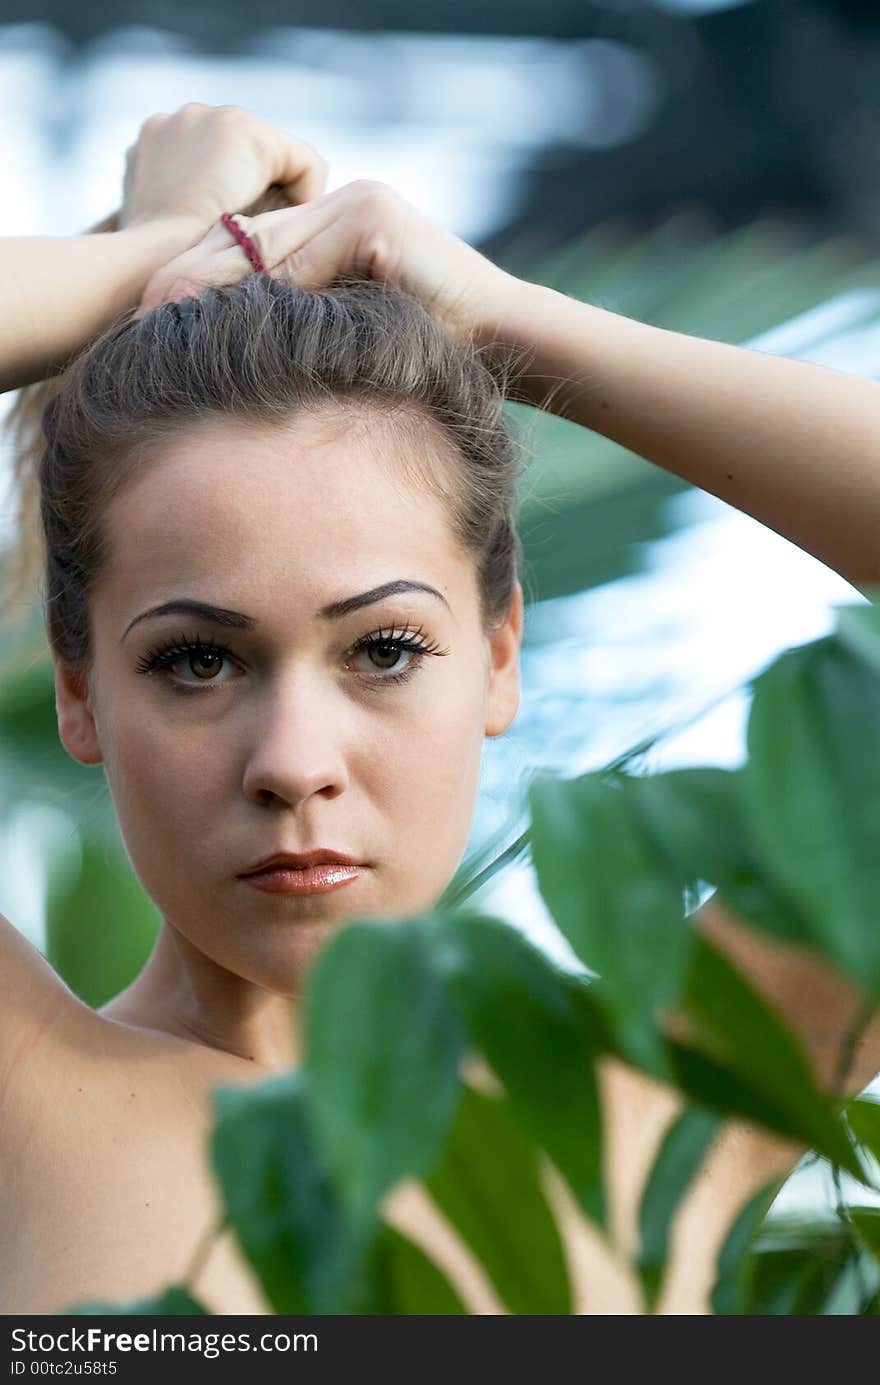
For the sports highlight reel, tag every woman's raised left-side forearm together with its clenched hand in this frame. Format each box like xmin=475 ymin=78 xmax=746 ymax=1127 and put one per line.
xmin=0 ymin=102 xmax=326 ymax=391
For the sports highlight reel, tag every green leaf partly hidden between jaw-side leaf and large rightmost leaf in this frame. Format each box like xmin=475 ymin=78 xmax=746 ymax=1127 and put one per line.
xmin=625 ymin=769 xmax=812 ymax=943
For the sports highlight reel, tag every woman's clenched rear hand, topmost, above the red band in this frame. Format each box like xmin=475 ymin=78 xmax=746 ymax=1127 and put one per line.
xmin=119 ymin=101 xmax=327 ymax=245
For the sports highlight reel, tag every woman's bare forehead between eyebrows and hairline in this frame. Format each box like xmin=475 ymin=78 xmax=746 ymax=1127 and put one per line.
xmin=96 ymin=418 xmax=473 ymax=625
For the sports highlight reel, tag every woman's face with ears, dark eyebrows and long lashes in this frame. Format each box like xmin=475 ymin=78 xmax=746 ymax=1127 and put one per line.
xmin=55 ymin=411 xmax=521 ymax=993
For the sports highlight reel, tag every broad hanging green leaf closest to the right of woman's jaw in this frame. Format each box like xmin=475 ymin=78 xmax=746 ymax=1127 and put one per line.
xmin=528 ymin=774 xmax=693 ymax=1078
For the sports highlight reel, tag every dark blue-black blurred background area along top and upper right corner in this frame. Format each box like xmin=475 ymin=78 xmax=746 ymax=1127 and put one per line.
xmin=0 ymin=0 xmax=880 ymax=256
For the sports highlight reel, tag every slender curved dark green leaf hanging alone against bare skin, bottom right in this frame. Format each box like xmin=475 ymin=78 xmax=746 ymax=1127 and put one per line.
xmin=637 ymin=1107 xmax=721 ymax=1312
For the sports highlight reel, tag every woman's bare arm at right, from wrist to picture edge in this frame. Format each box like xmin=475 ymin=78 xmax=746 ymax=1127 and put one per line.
xmin=488 ymin=281 xmax=880 ymax=586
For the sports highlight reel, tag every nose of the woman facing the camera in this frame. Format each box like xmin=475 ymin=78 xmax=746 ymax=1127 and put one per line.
xmin=244 ymin=670 xmax=348 ymax=807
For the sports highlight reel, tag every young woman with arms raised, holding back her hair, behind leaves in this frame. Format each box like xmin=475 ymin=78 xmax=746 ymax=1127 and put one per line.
xmin=0 ymin=107 xmax=880 ymax=1313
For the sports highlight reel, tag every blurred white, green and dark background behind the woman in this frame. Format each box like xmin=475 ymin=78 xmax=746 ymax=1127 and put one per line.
xmin=0 ymin=0 xmax=880 ymax=1213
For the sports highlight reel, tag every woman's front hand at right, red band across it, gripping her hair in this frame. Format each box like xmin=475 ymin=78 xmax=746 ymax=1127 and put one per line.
xmin=140 ymin=180 xmax=525 ymax=349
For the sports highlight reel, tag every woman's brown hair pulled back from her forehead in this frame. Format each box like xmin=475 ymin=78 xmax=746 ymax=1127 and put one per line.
xmin=1 ymin=210 xmax=524 ymax=672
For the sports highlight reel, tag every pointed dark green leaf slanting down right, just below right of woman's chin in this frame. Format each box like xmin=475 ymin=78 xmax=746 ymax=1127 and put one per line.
xmin=432 ymin=913 xmax=606 ymax=1226
